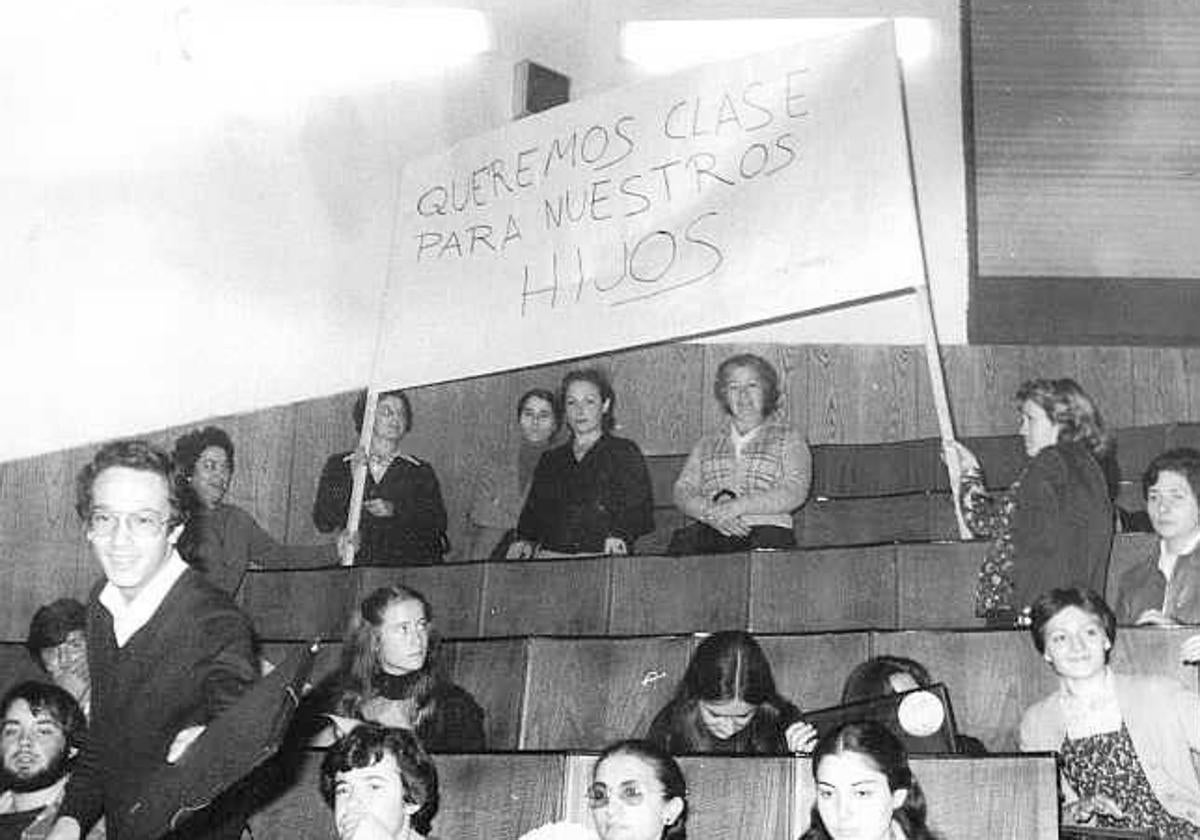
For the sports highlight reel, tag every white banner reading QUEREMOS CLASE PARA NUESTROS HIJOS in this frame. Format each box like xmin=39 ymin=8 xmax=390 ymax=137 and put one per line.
xmin=373 ymin=24 xmax=924 ymax=388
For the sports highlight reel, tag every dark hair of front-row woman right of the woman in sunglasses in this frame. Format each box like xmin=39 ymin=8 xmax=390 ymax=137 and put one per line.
xmin=804 ymin=720 xmax=934 ymax=840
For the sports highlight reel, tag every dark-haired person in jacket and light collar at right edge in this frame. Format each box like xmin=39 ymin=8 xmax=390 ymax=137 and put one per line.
xmin=1116 ymin=449 xmax=1200 ymax=625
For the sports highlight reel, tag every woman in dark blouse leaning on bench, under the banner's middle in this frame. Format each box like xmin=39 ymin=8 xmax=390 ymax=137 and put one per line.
xmin=508 ymin=368 xmax=654 ymax=558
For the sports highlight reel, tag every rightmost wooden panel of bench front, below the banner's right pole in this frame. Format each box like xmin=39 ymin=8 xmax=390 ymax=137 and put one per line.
xmin=896 ymin=541 xmax=990 ymax=630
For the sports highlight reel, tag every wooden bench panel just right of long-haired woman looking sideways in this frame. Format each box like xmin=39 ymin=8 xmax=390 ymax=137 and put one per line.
xmin=439 ymin=638 xmax=528 ymax=750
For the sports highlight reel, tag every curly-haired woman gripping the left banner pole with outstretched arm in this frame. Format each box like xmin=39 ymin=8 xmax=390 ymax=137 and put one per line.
xmin=172 ymin=426 xmax=347 ymax=594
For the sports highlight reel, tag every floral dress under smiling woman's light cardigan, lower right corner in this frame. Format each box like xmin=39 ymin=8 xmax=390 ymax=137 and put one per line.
xmin=1060 ymin=724 xmax=1200 ymax=840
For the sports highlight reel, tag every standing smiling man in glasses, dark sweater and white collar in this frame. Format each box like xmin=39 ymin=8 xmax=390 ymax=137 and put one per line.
xmin=49 ymin=440 xmax=257 ymax=840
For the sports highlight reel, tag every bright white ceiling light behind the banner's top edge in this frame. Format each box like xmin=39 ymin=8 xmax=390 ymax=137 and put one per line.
xmin=620 ymin=17 xmax=935 ymax=73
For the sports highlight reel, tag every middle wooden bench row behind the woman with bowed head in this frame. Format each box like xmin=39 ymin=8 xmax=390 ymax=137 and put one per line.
xmin=255 ymin=628 xmax=1196 ymax=751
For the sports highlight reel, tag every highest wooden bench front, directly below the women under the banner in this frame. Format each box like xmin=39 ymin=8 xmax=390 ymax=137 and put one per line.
xmin=241 ymin=534 xmax=1153 ymax=641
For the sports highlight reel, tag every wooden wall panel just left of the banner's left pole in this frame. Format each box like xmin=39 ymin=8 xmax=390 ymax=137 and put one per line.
xmin=280 ymin=391 xmax=359 ymax=544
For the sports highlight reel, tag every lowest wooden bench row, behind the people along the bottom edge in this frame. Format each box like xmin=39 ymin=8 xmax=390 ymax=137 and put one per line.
xmin=251 ymin=751 xmax=1058 ymax=840
